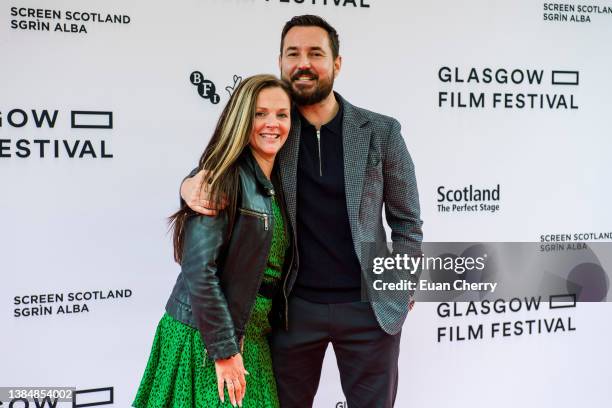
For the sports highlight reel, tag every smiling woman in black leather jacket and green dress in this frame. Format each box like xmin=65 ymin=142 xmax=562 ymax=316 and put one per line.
xmin=133 ymin=75 xmax=293 ymax=408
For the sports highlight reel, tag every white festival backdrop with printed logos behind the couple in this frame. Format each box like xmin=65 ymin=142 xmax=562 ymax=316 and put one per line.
xmin=0 ymin=0 xmax=612 ymax=408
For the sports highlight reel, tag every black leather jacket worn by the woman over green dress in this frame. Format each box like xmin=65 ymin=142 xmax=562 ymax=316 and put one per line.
xmin=166 ymin=148 xmax=295 ymax=360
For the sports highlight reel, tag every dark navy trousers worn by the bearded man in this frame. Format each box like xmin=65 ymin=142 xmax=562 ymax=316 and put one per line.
xmin=271 ymin=296 xmax=401 ymax=408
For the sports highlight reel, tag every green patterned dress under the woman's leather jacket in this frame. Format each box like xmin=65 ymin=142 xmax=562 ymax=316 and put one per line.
xmin=132 ymin=198 xmax=289 ymax=408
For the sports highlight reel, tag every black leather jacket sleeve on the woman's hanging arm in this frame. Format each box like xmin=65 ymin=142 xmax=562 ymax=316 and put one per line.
xmin=181 ymin=211 xmax=240 ymax=360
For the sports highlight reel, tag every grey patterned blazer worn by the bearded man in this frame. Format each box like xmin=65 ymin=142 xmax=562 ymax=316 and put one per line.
xmin=279 ymin=93 xmax=423 ymax=334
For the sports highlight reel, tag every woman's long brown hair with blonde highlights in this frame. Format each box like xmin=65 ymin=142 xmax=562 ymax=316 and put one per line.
xmin=169 ymin=74 xmax=291 ymax=264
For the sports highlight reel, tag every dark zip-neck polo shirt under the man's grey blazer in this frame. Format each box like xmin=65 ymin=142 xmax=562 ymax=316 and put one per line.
xmin=293 ymin=100 xmax=361 ymax=303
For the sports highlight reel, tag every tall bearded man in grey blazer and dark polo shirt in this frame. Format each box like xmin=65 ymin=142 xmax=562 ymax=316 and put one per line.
xmin=181 ymin=15 xmax=422 ymax=408
